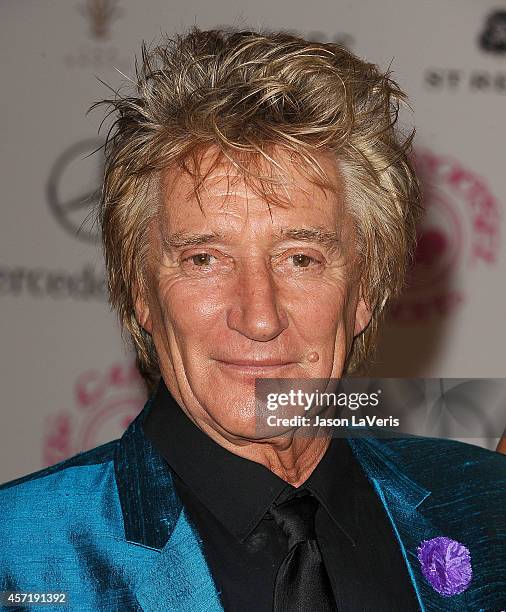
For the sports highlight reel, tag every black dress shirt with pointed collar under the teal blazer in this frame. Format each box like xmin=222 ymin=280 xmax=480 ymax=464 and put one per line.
xmin=144 ymin=380 xmax=420 ymax=612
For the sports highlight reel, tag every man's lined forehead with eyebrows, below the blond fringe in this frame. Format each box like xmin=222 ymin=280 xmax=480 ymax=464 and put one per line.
xmin=154 ymin=149 xmax=354 ymax=262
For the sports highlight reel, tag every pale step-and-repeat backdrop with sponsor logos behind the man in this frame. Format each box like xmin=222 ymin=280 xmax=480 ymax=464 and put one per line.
xmin=0 ymin=0 xmax=506 ymax=481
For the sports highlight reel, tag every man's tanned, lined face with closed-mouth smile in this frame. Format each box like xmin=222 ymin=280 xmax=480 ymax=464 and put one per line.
xmin=136 ymin=150 xmax=370 ymax=439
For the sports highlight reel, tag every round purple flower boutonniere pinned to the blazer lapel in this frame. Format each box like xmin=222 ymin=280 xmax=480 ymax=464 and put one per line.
xmin=418 ymin=536 xmax=473 ymax=597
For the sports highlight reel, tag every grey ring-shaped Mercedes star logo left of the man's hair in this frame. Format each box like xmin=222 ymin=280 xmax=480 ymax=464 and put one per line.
xmin=46 ymin=138 xmax=104 ymax=243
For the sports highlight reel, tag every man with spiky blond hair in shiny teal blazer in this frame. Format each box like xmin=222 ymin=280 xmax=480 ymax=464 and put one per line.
xmin=0 ymin=30 xmax=506 ymax=612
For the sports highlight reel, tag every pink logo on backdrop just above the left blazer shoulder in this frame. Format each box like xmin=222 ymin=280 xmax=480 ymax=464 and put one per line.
xmin=42 ymin=362 xmax=146 ymax=465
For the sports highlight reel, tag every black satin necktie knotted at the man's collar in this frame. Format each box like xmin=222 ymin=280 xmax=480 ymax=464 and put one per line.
xmin=270 ymin=495 xmax=337 ymax=612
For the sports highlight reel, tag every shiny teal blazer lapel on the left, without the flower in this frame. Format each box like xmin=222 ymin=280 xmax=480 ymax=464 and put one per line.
xmin=114 ymin=401 xmax=223 ymax=612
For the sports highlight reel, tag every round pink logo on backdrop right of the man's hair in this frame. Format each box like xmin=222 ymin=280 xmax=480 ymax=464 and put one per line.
xmin=390 ymin=151 xmax=500 ymax=323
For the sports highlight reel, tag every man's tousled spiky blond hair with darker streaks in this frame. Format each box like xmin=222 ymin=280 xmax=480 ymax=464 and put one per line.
xmin=99 ymin=28 xmax=420 ymax=389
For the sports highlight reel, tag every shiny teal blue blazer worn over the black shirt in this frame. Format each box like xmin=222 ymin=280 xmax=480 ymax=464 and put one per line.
xmin=0 ymin=401 xmax=506 ymax=612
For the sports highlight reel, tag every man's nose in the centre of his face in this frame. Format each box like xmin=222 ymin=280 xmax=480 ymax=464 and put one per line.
xmin=227 ymin=258 xmax=288 ymax=342
